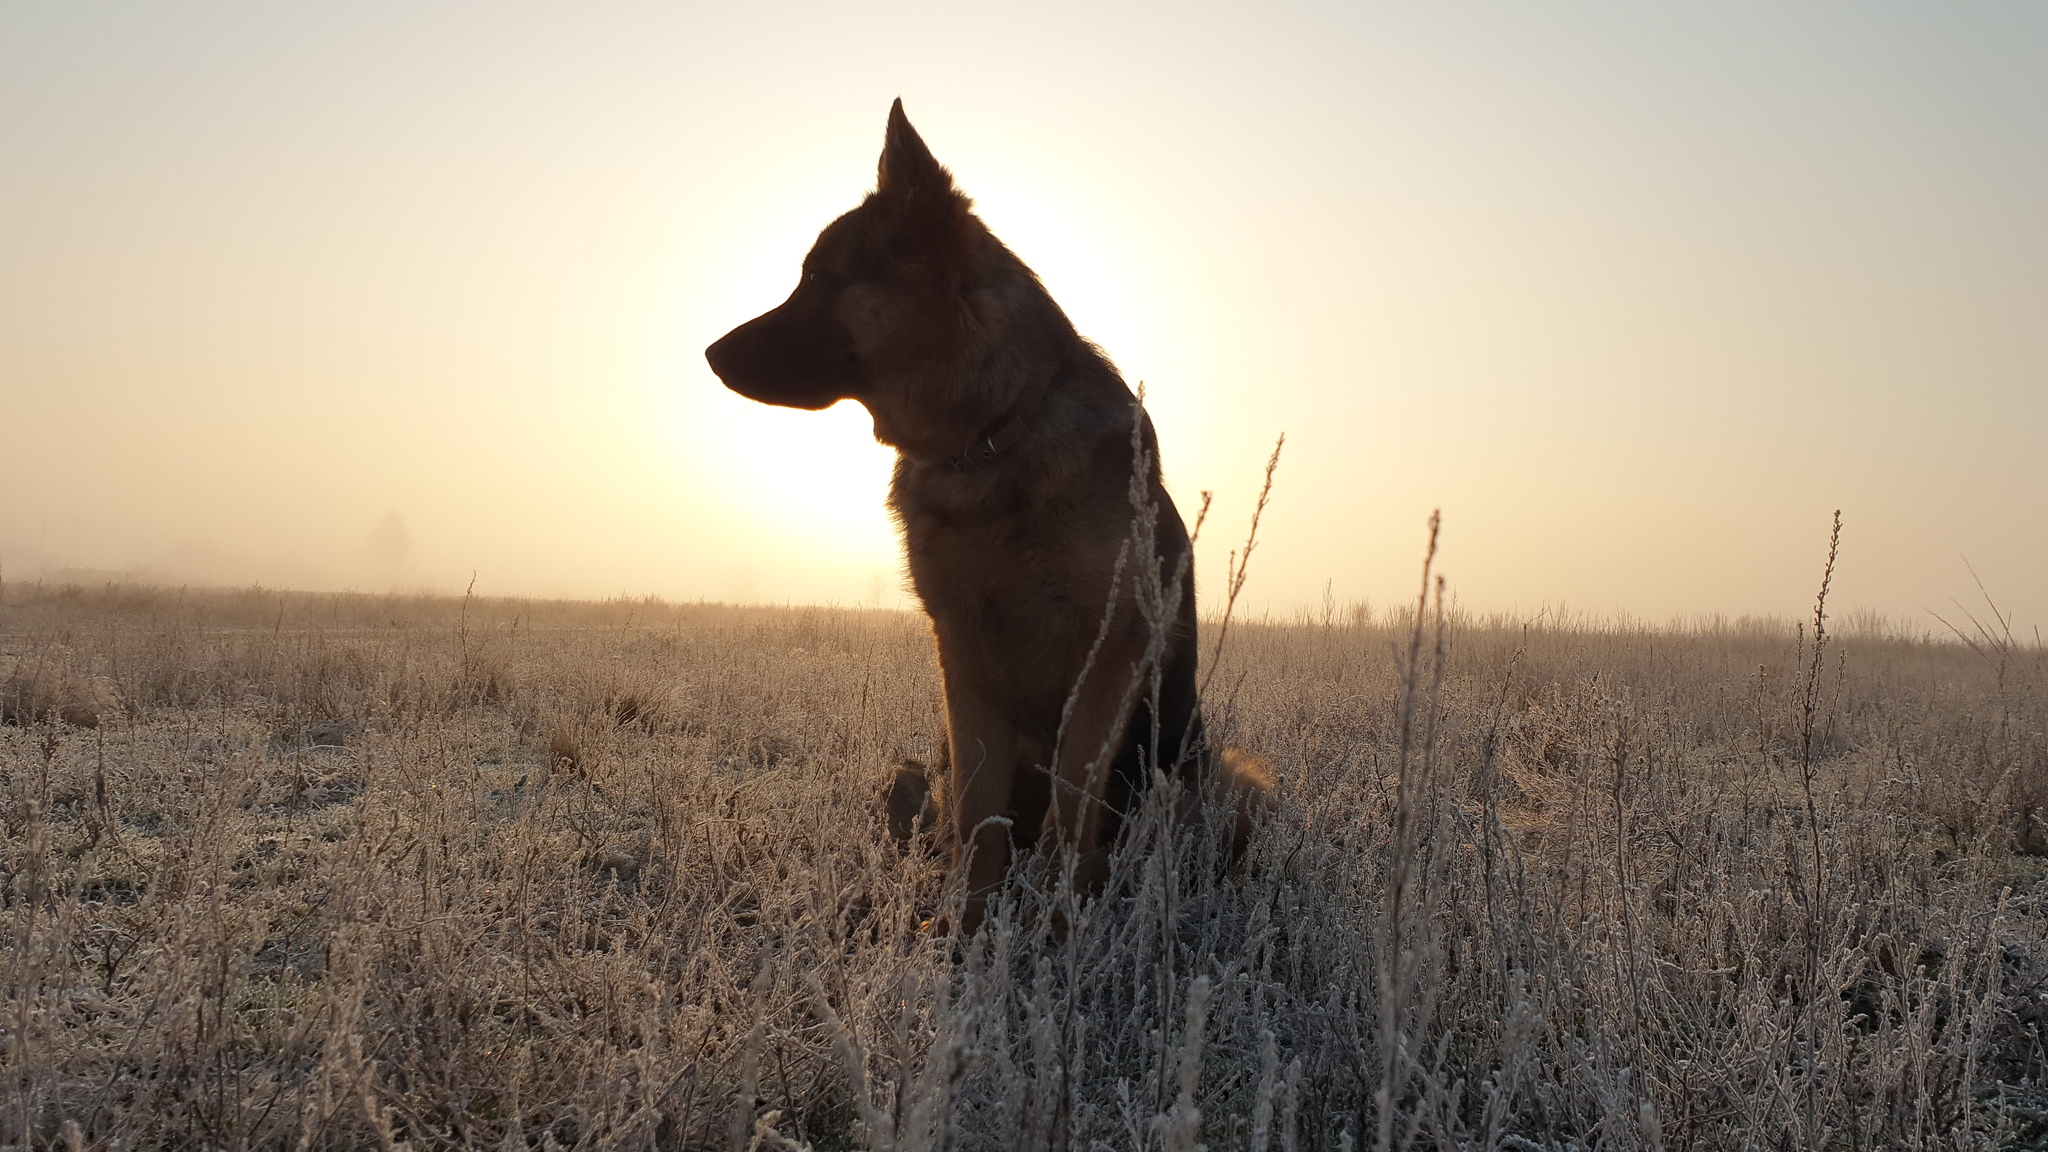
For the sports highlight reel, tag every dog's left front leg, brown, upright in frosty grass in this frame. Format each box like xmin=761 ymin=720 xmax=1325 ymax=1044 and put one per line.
xmin=946 ymin=676 xmax=1020 ymax=931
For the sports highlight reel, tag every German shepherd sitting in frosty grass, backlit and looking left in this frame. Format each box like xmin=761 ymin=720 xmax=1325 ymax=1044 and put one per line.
xmin=705 ymin=100 xmax=1270 ymax=929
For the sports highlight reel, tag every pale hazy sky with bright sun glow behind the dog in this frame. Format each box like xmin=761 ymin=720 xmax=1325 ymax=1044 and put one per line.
xmin=0 ymin=2 xmax=2048 ymax=627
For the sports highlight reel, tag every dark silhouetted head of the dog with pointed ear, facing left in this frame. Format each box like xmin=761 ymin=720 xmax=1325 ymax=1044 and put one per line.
xmin=705 ymin=100 xmax=1042 ymax=451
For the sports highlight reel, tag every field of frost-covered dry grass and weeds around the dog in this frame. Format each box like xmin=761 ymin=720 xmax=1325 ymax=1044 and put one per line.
xmin=0 ymin=582 xmax=2048 ymax=1152
